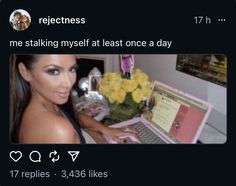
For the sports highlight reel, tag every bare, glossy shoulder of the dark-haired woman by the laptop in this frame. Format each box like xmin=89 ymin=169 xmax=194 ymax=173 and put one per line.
xmin=20 ymin=109 xmax=75 ymax=144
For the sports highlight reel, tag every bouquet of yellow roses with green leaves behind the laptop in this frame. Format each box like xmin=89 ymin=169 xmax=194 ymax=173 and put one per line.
xmin=99 ymin=69 xmax=151 ymax=125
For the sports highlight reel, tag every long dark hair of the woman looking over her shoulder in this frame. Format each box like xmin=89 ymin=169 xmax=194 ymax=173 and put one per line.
xmin=10 ymin=54 xmax=78 ymax=143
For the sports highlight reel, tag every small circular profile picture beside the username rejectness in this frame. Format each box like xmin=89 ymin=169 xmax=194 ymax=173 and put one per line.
xmin=9 ymin=9 xmax=31 ymax=31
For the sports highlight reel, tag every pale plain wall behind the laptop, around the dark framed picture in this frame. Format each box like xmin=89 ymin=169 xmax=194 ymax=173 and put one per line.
xmin=134 ymin=54 xmax=227 ymax=134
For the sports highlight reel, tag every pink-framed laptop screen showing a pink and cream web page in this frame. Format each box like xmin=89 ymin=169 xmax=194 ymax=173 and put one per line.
xmin=148 ymin=82 xmax=209 ymax=143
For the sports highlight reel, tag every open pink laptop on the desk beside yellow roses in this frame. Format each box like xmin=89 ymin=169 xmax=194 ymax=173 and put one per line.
xmin=108 ymin=81 xmax=212 ymax=144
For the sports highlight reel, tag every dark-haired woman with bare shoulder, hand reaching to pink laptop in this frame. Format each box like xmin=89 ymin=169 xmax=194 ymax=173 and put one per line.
xmin=10 ymin=54 xmax=135 ymax=144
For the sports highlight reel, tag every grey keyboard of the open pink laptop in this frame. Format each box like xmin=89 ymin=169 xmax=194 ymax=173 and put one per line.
xmin=131 ymin=122 xmax=166 ymax=144
